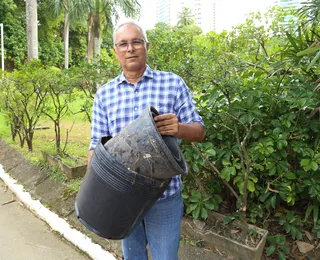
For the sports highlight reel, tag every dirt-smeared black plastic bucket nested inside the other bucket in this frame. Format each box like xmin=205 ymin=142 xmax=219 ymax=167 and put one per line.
xmin=105 ymin=107 xmax=187 ymax=180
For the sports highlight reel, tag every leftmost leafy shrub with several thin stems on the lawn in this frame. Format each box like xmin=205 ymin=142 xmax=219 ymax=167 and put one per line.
xmin=1 ymin=61 xmax=47 ymax=151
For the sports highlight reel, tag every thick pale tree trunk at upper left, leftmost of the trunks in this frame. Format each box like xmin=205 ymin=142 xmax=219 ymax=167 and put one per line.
xmin=26 ymin=0 xmax=39 ymax=61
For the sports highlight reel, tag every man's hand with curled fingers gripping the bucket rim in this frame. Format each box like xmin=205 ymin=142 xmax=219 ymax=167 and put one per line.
xmin=154 ymin=114 xmax=179 ymax=136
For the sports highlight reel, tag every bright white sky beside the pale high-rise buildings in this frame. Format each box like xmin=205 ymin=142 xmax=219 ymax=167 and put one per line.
xmin=131 ymin=0 xmax=273 ymax=32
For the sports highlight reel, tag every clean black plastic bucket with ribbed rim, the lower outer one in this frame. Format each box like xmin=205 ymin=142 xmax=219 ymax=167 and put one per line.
xmin=75 ymin=138 xmax=171 ymax=239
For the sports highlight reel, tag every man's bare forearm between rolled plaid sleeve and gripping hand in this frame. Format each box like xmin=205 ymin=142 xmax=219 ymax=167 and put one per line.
xmin=176 ymin=123 xmax=205 ymax=142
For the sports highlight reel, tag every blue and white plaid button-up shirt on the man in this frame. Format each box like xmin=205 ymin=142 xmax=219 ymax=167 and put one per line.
xmin=89 ymin=66 xmax=203 ymax=199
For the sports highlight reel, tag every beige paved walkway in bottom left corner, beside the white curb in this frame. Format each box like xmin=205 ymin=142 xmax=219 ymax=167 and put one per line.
xmin=0 ymin=179 xmax=91 ymax=260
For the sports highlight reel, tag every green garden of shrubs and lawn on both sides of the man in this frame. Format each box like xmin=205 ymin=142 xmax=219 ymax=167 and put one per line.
xmin=0 ymin=1 xmax=320 ymax=260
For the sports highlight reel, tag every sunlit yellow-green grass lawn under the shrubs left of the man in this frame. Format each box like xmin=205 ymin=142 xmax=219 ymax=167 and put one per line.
xmin=0 ymin=94 xmax=90 ymax=191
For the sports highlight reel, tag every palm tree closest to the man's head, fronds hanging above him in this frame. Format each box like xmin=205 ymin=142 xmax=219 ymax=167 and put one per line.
xmin=87 ymin=0 xmax=140 ymax=62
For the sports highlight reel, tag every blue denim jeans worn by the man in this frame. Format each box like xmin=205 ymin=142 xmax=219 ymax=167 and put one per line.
xmin=122 ymin=191 xmax=183 ymax=260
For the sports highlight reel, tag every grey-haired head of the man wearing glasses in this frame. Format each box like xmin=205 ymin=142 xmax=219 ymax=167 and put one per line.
xmin=113 ymin=20 xmax=149 ymax=72
